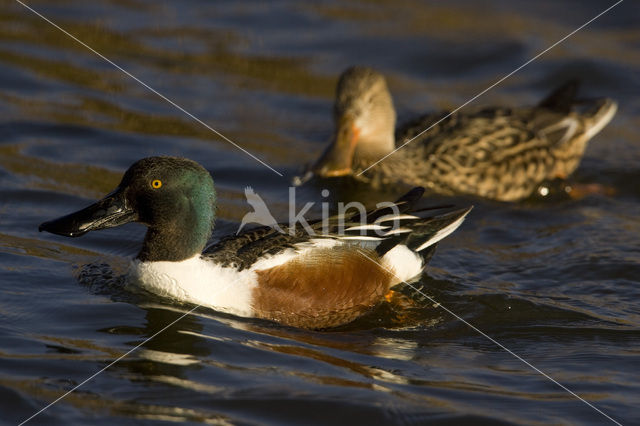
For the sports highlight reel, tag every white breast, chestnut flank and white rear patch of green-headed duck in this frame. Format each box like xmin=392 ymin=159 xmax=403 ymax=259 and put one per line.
xmin=128 ymin=241 xmax=425 ymax=329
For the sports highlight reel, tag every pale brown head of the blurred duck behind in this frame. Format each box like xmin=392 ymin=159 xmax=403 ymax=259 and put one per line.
xmin=312 ymin=67 xmax=396 ymax=177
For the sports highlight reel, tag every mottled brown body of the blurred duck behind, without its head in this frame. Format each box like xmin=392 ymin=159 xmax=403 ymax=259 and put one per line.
xmin=372 ymin=99 xmax=615 ymax=201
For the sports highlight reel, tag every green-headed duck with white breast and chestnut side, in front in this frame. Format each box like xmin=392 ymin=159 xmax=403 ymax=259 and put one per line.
xmin=39 ymin=157 xmax=470 ymax=328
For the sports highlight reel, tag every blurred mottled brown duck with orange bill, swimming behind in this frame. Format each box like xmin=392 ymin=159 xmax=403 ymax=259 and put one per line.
xmin=297 ymin=67 xmax=617 ymax=201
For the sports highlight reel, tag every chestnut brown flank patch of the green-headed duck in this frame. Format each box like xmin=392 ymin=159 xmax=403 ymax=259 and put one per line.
xmin=252 ymin=246 xmax=394 ymax=328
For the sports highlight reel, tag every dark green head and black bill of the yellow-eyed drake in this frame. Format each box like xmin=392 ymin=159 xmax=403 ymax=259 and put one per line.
xmin=39 ymin=157 xmax=216 ymax=261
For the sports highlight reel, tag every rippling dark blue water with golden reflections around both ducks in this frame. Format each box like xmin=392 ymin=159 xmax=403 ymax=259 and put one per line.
xmin=0 ymin=0 xmax=640 ymax=425
